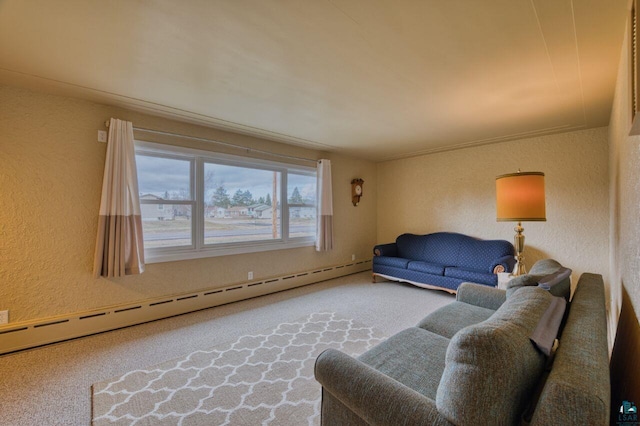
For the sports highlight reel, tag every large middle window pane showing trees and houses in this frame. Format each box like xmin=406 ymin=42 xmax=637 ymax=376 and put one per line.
xmin=204 ymin=163 xmax=282 ymax=244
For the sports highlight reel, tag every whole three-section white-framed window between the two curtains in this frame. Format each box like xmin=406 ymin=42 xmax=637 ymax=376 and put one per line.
xmin=136 ymin=142 xmax=316 ymax=262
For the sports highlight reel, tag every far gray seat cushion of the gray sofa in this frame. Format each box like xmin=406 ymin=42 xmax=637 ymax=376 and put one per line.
xmin=417 ymin=302 xmax=495 ymax=339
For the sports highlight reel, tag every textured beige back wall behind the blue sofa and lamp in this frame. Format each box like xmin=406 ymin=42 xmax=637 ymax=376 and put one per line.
xmin=378 ymin=128 xmax=609 ymax=290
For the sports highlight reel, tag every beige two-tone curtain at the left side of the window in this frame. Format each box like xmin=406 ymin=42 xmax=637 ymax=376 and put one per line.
xmin=93 ymin=118 xmax=144 ymax=278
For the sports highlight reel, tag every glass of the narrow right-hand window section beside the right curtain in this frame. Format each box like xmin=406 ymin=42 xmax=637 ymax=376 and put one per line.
xmin=287 ymin=173 xmax=316 ymax=238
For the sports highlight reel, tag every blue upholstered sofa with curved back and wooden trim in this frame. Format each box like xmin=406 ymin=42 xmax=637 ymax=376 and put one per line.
xmin=373 ymin=232 xmax=516 ymax=293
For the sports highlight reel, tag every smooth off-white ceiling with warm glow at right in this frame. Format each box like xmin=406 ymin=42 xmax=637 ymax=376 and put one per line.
xmin=0 ymin=0 xmax=628 ymax=160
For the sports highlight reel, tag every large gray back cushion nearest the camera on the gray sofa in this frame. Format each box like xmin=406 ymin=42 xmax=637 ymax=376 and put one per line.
xmin=436 ymin=287 xmax=552 ymax=424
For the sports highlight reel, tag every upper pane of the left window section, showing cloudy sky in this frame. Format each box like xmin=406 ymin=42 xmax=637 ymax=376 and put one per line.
xmin=136 ymin=154 xmax=192 ymax=200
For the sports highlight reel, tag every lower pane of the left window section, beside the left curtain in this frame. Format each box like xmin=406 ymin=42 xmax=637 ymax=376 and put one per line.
xmin=140 ymin=203 xmax=192 ymax=248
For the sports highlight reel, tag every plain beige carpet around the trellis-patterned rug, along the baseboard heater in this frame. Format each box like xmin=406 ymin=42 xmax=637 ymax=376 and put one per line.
xmin=0 ymin=272 xmax=454 ymax=426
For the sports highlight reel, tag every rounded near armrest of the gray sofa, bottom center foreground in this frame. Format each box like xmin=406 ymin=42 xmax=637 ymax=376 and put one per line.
xmin=315 ymin=349 xmax=451 ymax=425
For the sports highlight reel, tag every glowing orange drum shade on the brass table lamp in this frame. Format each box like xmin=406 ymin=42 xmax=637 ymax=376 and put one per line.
xmin=496 ymin=172 xmax=547 ymax=222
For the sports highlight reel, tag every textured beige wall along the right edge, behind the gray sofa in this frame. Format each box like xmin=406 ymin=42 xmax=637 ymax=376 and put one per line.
xmin=609 ymin=15 xmax=640 ymax=332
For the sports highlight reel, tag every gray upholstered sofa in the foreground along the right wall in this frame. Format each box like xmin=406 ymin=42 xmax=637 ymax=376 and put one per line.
xmin=315 ymin=260 xmax=610 ymax=426
